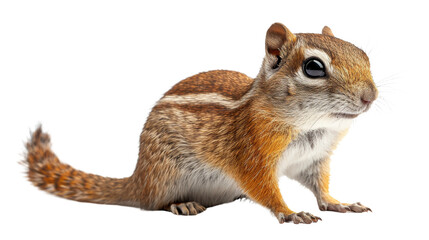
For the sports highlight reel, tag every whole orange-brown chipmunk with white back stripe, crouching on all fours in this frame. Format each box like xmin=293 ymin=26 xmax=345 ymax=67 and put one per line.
xmin=24 ymin=23 xmax=378 ymax=224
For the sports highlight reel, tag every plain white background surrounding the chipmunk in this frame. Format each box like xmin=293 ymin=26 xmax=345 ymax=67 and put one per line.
xmin=0 ymin=0 xmax=429 ymax=239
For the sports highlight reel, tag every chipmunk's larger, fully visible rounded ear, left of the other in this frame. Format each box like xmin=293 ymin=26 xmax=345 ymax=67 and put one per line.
xmin=265 ymin=23 xmax=296 ymax=56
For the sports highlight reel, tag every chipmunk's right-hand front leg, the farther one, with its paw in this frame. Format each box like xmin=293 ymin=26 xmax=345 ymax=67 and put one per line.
xmin=294 ymin=158 xmax=372 ymax=213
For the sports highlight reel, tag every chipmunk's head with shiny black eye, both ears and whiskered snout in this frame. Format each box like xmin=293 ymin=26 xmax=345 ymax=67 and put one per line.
xmin=256 ymin=23 xmax=378 ymax=130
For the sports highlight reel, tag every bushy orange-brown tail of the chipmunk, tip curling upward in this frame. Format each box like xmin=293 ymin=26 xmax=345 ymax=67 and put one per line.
xmin=24 ymin=127 xmax=139 ymax=206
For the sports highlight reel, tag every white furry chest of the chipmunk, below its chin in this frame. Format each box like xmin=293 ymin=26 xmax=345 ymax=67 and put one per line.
xmin=278 ymin=129 xmax=339 ymax=178
